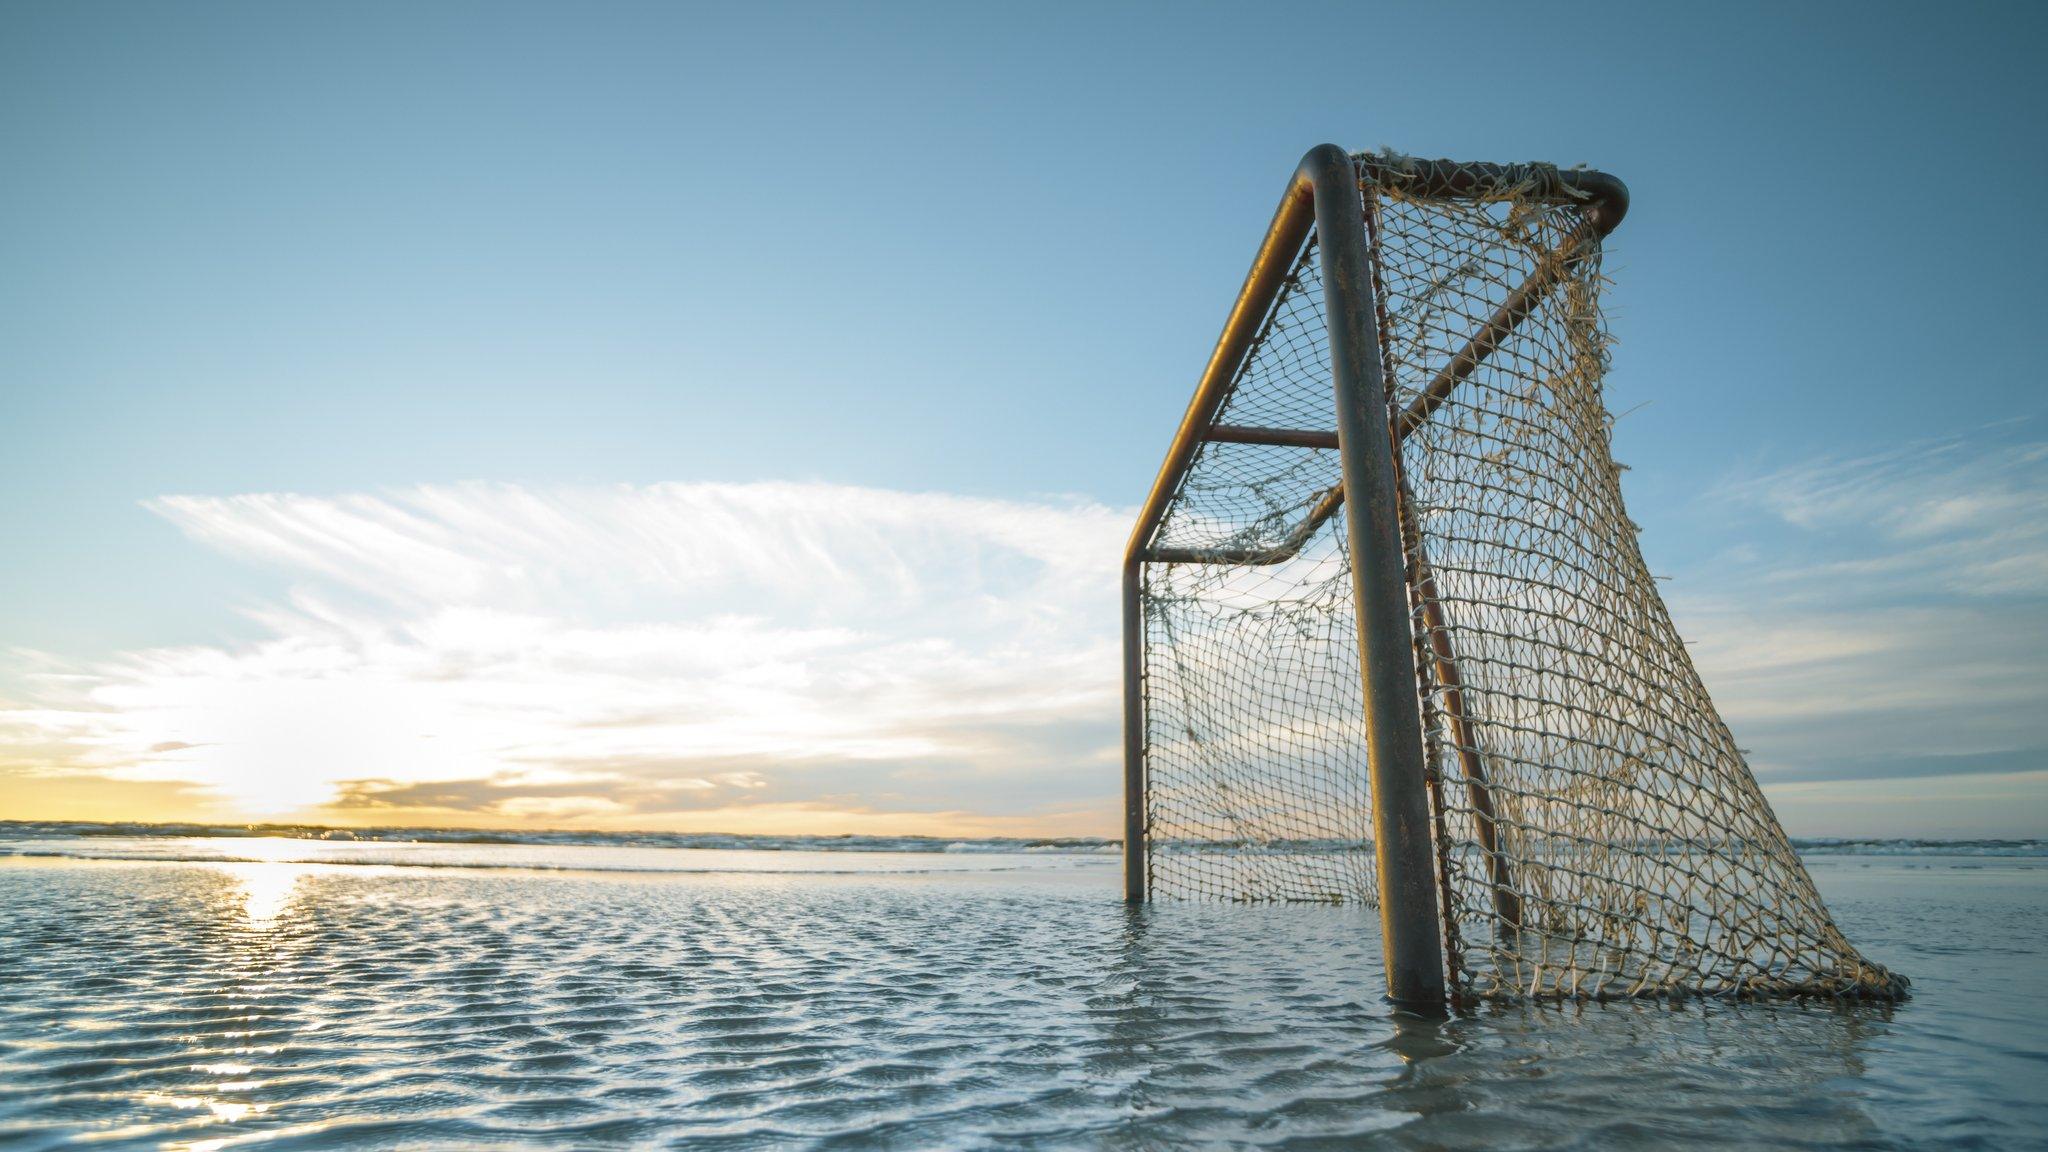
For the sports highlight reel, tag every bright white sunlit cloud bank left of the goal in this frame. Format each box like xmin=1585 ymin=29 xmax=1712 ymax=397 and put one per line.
xmin=8 ymin=484 xmax=1128 ymax=828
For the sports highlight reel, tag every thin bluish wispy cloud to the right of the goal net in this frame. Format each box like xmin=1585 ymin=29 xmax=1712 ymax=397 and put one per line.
xmin=1667 ymin=420 xmax=2048 ymax=818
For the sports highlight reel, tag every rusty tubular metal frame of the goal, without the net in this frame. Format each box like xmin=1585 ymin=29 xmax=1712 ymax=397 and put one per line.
xmin=1122 ymin=143 xmax=1628 ymax=1013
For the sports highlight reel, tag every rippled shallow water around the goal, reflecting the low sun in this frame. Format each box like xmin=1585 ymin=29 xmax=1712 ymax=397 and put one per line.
xmin=0 ymin=840 xmax=2048 ymax=1148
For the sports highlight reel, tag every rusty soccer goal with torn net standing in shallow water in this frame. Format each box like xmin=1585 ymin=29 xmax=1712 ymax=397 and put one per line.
xmin=1122 ymin=146 xmax=1905 ymax=1006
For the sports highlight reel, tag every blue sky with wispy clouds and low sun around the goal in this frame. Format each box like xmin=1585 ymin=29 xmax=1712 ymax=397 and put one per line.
xmin=0 ymin=2 xmax=2048 ymax=836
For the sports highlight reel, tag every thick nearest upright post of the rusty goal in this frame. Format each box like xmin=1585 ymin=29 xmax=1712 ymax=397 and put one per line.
xmin=1300 ymin=146 xmax=1444 ymax=1013
